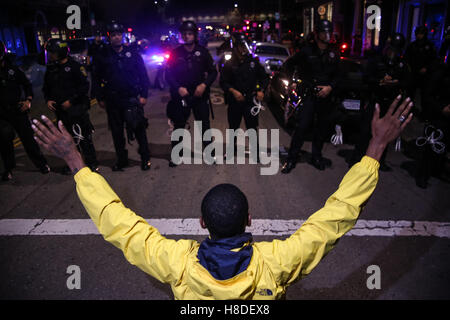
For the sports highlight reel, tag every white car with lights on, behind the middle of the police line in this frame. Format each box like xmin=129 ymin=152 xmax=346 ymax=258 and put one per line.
xmin=252 ymin=42 xmax=290 ymax=74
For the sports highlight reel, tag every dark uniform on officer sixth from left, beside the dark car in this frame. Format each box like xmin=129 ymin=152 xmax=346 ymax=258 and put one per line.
xmin=283 ymin=42 xmax=340 ymax=168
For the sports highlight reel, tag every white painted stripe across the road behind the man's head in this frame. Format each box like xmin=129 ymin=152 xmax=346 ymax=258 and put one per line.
xmin=0 ymin=219 xmax=450 ymax=238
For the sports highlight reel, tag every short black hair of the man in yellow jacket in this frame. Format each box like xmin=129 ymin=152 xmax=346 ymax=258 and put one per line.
xmin=201 ymin=184 xmax=248 ymax=239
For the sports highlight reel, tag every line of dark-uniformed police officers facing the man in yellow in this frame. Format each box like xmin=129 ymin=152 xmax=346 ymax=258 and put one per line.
xmin=0 ymin=20 xmax=450 ymax=188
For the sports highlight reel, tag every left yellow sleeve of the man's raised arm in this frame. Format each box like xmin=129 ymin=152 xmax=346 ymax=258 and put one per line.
xmin=74 ymin=167 xmax=196 ymax=284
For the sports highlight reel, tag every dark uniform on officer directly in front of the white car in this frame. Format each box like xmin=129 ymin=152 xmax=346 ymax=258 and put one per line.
xmin=220 ymin=55 xmax=269 ymax=130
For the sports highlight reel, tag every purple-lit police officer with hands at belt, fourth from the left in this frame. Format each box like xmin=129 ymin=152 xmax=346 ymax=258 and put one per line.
xmin=166 ymin=21 xmax=217 ymax=167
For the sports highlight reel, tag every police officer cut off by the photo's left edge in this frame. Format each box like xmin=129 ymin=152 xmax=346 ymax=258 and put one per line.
xmin=0 ymin=41 xmax=50 ymax=181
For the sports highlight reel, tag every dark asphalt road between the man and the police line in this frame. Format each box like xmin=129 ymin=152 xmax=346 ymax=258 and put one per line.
xmin=0 ymin=43 xmax=450 ymax=300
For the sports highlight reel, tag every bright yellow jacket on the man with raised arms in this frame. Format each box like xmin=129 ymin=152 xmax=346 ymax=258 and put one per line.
xmin=75 ymin=156 xmax=379 ymax=300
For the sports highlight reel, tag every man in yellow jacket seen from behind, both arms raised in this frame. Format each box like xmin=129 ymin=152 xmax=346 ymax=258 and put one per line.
xmin=29 ymin=96 xmax=412 ymax=299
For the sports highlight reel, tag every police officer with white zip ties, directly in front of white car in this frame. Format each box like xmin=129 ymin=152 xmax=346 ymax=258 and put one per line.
xmin=220 ymin=34 xmax=269 ymax=158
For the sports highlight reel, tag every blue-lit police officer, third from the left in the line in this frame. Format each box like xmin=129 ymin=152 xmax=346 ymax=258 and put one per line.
xmin=93 ymin=21 xmax=151 ymax=171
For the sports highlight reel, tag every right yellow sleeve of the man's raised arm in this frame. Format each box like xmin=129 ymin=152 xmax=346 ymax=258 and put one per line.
xmin=255 ymin=156 xmax=379 ymax=285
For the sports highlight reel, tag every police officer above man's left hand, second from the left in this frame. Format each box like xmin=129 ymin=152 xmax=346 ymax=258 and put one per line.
xmin=42 ymin=39 xmax=98 ymax=173
